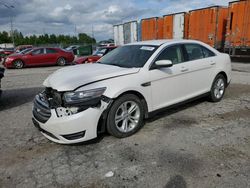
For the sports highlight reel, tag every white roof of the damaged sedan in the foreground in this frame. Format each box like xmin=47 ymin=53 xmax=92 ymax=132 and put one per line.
xmin=127 ymin=39 xmax=205 ymax=46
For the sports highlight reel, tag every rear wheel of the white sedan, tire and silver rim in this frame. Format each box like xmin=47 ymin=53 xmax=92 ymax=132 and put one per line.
xmin=210 ymin=74 xmax=226 ymax=102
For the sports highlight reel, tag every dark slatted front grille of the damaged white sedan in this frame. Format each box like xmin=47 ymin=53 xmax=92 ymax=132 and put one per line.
xmin=33 ymin=94 xmax=51 ymax=123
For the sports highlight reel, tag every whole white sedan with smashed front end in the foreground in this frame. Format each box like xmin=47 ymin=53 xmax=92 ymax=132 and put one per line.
xmin=32 ymin=40 xmax=231 ymax=144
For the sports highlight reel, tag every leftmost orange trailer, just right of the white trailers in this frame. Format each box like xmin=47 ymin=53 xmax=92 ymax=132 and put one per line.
xmin=141 ymin=17 xmax=163 ymax=41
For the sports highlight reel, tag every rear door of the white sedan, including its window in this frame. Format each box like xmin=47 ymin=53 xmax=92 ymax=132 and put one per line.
xmin=184 ymin=44 xmax=216 ymax=98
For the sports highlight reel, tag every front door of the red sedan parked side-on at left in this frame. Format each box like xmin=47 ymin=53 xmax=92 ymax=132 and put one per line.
xmin=26 ymin=48 xmax=45 ymax=65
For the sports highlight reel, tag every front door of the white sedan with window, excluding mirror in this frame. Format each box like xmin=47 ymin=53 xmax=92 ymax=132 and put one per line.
xmin=149 ymin=45 xmax=188 ymax=110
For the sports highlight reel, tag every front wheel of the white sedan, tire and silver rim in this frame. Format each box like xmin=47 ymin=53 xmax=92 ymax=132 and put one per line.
xmin=107 ymin=94 xmax=144 ymax=138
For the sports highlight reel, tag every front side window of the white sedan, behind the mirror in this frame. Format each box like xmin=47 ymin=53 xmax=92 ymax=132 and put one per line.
xmin=156 ymin=45 xmax=184 ymax=64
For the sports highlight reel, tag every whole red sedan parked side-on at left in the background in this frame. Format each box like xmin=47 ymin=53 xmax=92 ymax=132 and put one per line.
xmin=3 ymin=48 xmax=74 ymax=69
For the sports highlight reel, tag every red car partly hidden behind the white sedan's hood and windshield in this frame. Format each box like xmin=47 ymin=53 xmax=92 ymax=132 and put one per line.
xmin=74 ymin=46 xmax=117 ymax=64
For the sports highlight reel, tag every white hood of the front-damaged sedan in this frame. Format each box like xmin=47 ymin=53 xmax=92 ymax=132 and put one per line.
xmin=43 ymin=63 xmax=140 ymax=91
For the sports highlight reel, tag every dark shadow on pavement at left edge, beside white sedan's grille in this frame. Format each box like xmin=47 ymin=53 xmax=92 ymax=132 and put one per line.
xmin=0 ymin=87 xmax=43 ymax=111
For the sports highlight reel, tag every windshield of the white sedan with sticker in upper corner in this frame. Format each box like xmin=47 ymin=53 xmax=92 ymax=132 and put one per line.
xmin=98 ymin=45 xmax=158 ymax=68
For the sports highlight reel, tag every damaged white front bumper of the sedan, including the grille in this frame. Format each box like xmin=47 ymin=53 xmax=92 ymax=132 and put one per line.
xmin=32 ymin=89 xmax=111 ymax=144
